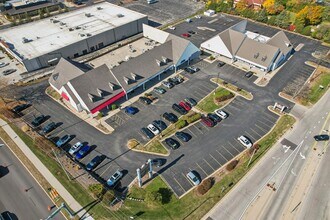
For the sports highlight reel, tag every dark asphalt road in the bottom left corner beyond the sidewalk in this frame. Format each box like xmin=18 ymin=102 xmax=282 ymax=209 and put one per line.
xmin=0 ymin=140 xmax=65 ymax=219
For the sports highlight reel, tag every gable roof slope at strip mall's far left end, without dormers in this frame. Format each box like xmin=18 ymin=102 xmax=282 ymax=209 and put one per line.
xmin=48 ymin=58 xmax=84 ymax=90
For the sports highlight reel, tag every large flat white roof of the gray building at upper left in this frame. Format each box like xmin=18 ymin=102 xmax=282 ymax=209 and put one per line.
xmin=0 ymin=2 xmax=147 ymax=59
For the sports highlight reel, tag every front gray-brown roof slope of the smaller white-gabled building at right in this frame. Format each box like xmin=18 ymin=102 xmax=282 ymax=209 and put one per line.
xmin=236 ymin=38 xmax=279 ymax=68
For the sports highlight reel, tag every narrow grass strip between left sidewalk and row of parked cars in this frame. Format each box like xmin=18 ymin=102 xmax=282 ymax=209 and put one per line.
xmin=11 ymin=125 xmax=118 ymax=219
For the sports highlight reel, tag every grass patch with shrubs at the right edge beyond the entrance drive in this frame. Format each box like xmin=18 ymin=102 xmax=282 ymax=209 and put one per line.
xmin=300 ymin=72 xmax=330 ymax=105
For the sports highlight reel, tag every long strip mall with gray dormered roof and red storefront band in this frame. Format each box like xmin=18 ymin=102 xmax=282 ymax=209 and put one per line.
xmin=49 ymin=25 xmax=200 ymax=114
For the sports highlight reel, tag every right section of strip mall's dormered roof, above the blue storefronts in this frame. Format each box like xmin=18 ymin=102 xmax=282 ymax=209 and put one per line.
xmin=111 ymin=40 xmax=174 ymax=91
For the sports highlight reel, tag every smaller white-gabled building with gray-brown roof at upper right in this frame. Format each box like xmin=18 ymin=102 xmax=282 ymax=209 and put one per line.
xmin=201 ymin=20 xmax=293 ymax=72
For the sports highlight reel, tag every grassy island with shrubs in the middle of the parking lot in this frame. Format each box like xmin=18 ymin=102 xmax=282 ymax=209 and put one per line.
xmin=196 ymin=87 xmax=231 ymax=113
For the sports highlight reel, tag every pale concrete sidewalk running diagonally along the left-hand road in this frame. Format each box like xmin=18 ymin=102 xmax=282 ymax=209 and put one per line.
xmin=0 ymin=119 xmax=93 ymax=220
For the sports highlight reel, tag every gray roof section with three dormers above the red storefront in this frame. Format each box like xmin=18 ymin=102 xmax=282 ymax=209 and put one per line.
xmin=70 ymin=64 xmax=123 ymax=110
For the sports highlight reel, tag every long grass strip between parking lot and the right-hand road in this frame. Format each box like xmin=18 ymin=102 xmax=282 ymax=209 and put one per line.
xmin=121 ymin=115 xmax=295 ymax=219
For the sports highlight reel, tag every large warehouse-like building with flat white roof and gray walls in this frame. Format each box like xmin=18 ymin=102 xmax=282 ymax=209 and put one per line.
xmin=0 ymin=2 xmax=148 ymax=71
